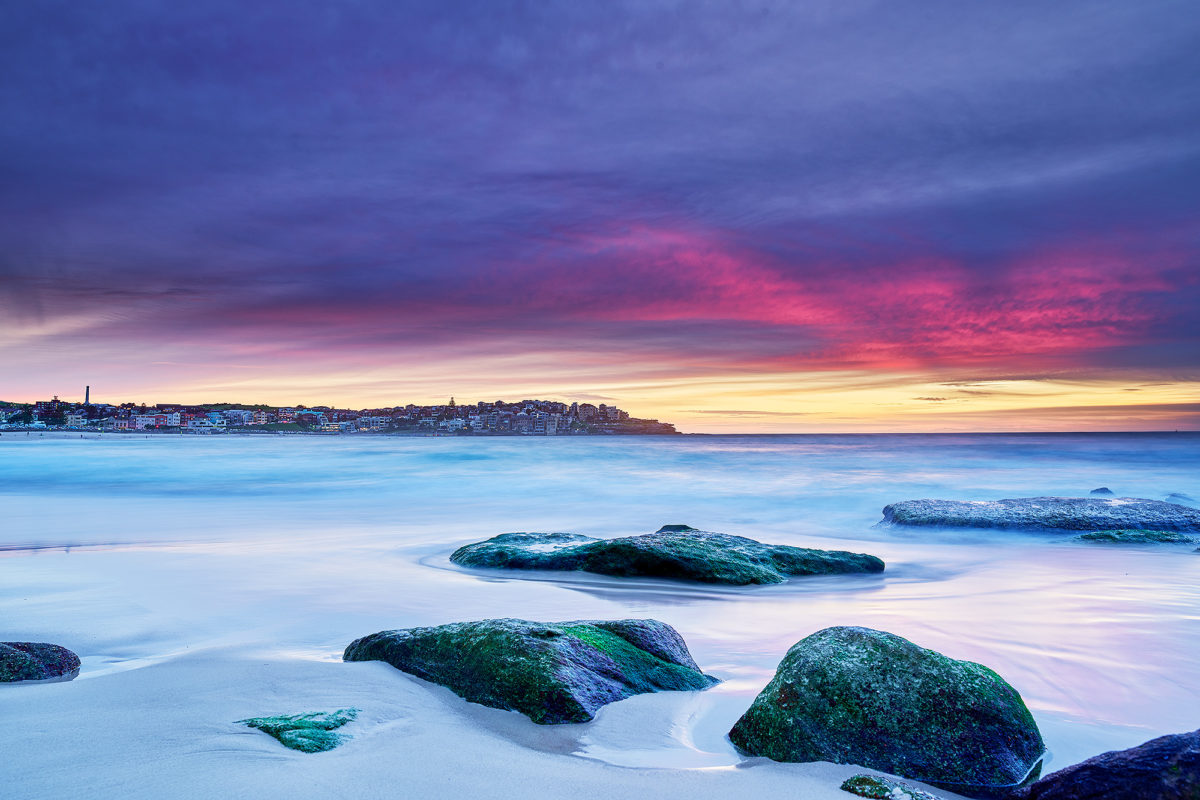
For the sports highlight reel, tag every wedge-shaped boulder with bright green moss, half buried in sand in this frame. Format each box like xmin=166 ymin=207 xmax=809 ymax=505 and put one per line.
xmin=343 ymin=619 xmax=718 ymax=724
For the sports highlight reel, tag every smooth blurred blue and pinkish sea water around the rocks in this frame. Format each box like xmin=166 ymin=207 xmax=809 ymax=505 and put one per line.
xmin=0 ymin=433 xmax=1200 ymax=769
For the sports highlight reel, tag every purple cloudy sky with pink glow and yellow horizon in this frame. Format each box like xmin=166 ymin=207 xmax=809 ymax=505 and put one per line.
xmin=0 ymin=0 xmax=1200 ymax=433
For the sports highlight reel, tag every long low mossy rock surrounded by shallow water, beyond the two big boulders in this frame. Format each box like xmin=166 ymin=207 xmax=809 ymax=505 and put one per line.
xmin=450 ymin=525 xmax=883 ymax=585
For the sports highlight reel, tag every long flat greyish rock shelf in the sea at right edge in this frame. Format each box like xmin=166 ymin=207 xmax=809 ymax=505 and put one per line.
xmin=883 ymin=498 xmax=1200 ymax=531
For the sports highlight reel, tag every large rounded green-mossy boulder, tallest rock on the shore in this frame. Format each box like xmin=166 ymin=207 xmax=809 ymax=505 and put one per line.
xmin=730 ymin=627 xmax=1045 ymax=796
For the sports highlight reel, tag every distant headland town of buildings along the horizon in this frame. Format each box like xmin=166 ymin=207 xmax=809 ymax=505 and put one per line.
xmin=0 ymin=386 xmax=678 ymax=437
